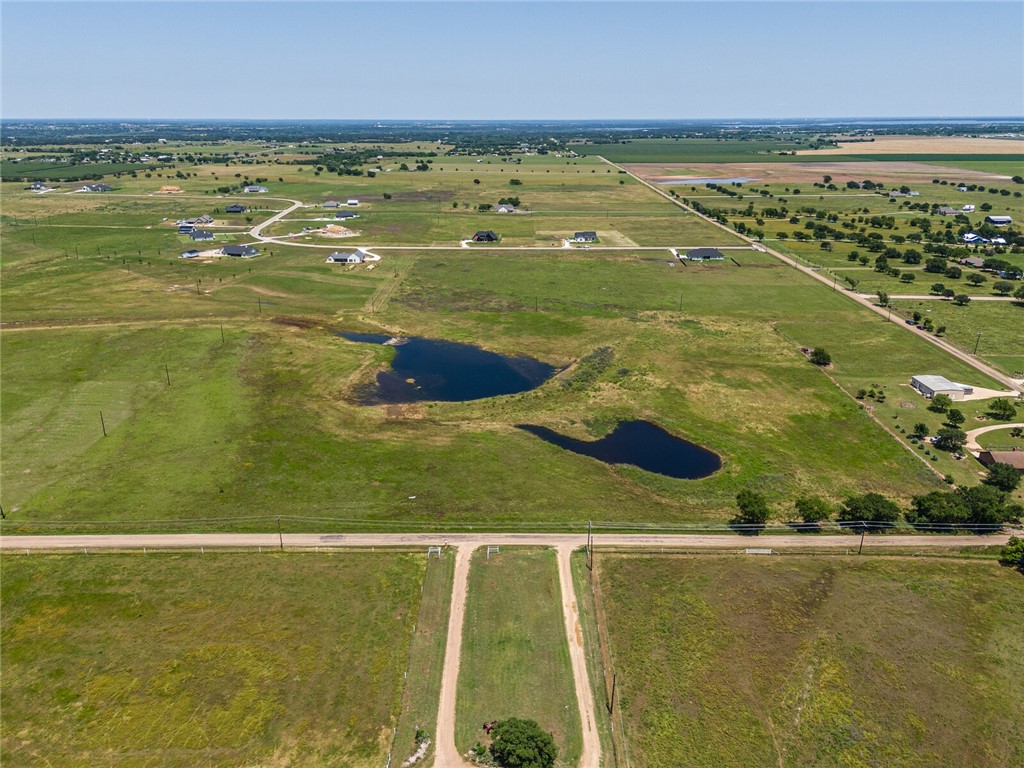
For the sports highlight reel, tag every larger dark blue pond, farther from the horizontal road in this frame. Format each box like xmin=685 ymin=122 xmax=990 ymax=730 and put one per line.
xmin=339 ymin=333 xmax=556 ymax=404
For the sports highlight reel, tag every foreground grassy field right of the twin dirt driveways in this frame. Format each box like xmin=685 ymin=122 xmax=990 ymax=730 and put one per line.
xmin=598 ymin=555 xmax=1024 ymax=768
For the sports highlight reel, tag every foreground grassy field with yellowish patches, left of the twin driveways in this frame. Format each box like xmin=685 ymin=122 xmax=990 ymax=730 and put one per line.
xmin=0 ymin=554 xmax=423 ymax=766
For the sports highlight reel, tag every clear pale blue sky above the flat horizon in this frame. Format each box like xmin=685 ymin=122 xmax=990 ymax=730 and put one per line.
xmin=0 ymin=0 xmax=1024 ymax=120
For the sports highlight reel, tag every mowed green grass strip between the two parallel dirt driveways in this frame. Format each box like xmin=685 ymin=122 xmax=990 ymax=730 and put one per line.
xmin=455 ymin=549 xmax=582 ymax=767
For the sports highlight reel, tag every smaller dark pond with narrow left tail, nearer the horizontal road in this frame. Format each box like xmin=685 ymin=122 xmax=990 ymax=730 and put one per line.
xmin=516 ymin=421 xmax=722 ymax=480
